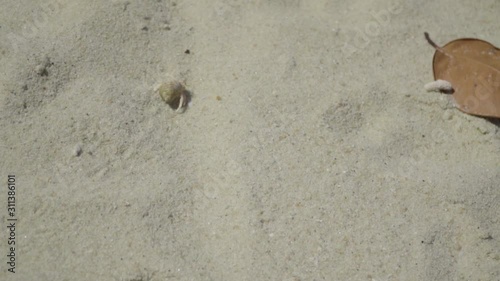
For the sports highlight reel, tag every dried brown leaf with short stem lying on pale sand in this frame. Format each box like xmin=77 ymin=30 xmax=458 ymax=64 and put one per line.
xmin=425 ymin=32 xmax=500 ymax=118
